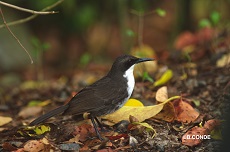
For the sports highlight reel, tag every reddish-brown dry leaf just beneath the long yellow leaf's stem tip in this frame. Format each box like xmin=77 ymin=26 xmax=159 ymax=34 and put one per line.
xmin=173 ymin=99 xmax=199 ymax=123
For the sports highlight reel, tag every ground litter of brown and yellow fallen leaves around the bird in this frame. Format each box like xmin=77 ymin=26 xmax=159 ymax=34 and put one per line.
xmin=0 ymin=30 xmax=230 ymax=152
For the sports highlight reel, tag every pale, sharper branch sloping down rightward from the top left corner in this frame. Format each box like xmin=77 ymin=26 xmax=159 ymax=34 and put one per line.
xmin=0 ymin=1 xmax=57 ymax=15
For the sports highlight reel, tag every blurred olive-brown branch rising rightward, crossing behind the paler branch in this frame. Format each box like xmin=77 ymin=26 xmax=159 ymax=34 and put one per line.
xmin=0 ymin=0 xmax=64 ymax=29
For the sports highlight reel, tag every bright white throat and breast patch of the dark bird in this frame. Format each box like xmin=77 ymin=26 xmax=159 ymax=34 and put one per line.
xmin=123 ymin=65 xmax=135 ymax=100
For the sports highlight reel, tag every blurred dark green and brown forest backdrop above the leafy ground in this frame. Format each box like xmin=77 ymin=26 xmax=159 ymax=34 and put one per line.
xmin=0 ymin=0 xmax=230 ymax=77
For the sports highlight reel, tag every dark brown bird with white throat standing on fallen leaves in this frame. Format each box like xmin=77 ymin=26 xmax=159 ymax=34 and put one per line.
xmin=29 ymin=54 xmax=154 ymax=140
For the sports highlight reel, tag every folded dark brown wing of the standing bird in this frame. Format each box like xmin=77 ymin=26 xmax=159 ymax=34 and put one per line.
xmin=64 ymin=77 xmax=128 ymax=115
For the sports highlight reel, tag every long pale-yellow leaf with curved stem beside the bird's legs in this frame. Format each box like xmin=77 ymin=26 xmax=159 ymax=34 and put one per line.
xmin=102 ymin=96 xmax=180 ymax=123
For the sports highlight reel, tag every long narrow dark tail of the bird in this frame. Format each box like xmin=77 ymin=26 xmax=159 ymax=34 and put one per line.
xmin=30 ymin=105 xmax=69 ymax=126
